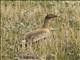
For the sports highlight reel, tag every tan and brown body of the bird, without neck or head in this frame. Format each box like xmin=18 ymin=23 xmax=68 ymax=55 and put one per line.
xmin=25 ymin=29 xmax=50 ymax=42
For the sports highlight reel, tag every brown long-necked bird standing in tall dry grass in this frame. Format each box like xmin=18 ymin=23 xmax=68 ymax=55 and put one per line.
xmin=24 ymin=14 xmax=58 ymax=43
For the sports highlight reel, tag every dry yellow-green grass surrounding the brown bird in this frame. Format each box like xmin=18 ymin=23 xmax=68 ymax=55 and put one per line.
xmin=1 ymin=1 xmax=80 ymax=60
